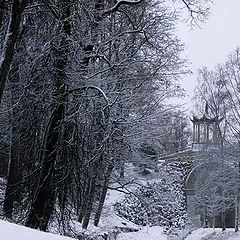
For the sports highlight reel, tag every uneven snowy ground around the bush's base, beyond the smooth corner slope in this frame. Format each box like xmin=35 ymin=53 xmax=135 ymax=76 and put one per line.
xmin=74 ymin=165 xmax=240 ymax=240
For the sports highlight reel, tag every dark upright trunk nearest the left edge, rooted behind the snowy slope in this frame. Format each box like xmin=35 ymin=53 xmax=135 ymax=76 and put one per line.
xmin=3 ymin=18 xmax=34 ymax=219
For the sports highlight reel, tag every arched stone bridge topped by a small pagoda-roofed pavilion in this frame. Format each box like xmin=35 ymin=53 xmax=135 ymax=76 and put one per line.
xmin=158 ymin=104 xmax=238 ymax=227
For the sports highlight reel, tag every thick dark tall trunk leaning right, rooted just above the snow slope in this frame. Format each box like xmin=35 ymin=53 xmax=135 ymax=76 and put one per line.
xmin=26 ymin=0 xmax=71 ymax=231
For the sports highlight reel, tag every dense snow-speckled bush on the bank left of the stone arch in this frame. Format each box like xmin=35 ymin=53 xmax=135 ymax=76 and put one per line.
xmin=115 ymin=161 xmax=190 ymax=228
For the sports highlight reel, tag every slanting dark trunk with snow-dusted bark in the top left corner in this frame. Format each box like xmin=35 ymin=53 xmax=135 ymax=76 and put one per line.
xmin=0 ymin=0 xmax=28 ymax=104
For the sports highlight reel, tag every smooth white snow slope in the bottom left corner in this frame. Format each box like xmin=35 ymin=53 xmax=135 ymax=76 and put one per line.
xmin=0 ymin=220 xmax=74 ymax=240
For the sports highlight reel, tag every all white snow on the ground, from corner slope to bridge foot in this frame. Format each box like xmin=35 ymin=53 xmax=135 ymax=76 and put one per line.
xmin=0 ymin=167 xmax=240 ymax=240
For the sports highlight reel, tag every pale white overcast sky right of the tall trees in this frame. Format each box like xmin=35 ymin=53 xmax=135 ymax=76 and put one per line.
xmin=179 ymin=0 xmax=240 ymax=110
